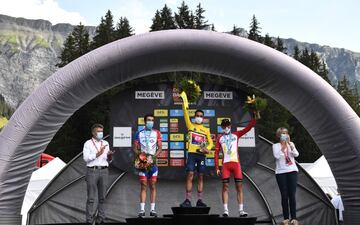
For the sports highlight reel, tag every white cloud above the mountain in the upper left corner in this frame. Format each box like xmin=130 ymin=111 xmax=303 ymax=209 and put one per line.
xmin=0 ymin=0 xmax=86 ymax=25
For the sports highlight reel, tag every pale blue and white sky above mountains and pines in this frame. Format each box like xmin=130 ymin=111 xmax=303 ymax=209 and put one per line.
xmin=0 ymin=0 xmax=360 ymax=52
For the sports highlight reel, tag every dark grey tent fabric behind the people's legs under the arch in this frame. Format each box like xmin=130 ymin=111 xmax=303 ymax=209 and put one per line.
xmin=28 ymin=137 xmax=336 ymax=225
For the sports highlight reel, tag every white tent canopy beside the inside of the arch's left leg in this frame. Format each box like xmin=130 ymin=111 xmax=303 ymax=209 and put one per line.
xmin=21 ymin=157 xmax=66 ymax=225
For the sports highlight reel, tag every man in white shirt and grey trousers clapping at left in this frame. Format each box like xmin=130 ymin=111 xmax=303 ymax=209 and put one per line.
xmin=83 ymin=124 xmax=113 ymax=224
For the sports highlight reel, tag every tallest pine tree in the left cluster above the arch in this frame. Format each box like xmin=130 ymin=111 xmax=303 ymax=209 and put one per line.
xmin=91 ymin=10 xmax=115 ymax=49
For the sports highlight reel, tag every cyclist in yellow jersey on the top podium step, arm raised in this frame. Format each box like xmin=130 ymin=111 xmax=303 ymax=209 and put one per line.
xmin=180 ymin=94 xmax=214 ymax=207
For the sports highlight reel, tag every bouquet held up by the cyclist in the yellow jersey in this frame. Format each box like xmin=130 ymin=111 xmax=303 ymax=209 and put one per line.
xmin=175 ymin=78 xmax=201 ymax=103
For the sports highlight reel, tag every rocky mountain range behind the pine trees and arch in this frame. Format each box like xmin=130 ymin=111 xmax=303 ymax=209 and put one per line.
xmin=0 ymin=15 xmax=360 ymax=108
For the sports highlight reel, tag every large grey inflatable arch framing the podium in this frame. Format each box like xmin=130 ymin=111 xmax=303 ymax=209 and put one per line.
xmin=0 ymin=30 xmax=360 ymax=225
